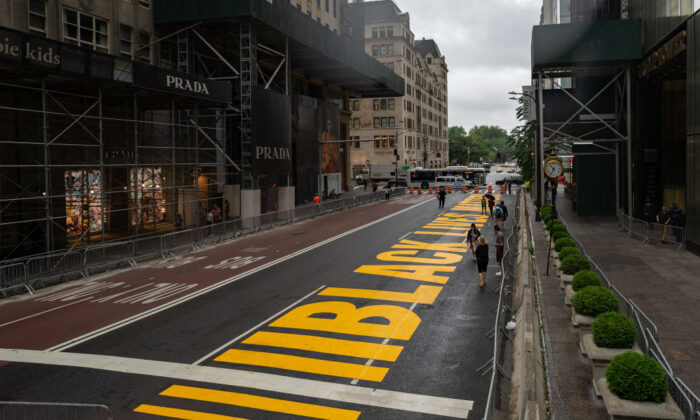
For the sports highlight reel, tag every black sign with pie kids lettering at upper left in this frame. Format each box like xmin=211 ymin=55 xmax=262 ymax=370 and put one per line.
xmin=0 ymin=28 xmax=114 ymax=79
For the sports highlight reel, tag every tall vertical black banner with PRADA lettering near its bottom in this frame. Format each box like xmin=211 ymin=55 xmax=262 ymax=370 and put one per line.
xmin=252 ymin=88 xmax=292 ymax=175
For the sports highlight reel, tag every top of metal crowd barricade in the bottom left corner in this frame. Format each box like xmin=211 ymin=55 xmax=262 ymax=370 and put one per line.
xmin=0 ymin=401 xmax=114 ymax=420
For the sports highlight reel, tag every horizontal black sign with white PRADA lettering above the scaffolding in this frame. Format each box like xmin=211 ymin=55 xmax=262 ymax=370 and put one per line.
xmin=134 ymin=62 xmax=233 ymax=104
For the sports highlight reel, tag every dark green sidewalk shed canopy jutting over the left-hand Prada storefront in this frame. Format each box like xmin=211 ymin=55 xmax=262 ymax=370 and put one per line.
xmin=154 ymin=0 xmax=405 ymax=97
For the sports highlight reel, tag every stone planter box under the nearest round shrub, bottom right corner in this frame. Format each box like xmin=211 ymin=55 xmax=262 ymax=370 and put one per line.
xmin=598 ymin=378 xmax=685 ymax=420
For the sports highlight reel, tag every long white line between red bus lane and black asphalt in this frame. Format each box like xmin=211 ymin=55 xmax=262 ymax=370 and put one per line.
xmin=47 ymin=197 xmax=430 ymax=351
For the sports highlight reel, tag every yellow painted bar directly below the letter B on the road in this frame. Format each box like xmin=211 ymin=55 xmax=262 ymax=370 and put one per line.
xmin=243 ymin=331 xmax=403 ymax=362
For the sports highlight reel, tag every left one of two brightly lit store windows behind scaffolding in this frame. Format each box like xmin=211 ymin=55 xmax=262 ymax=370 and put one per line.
xmin=64 ymin=170 xmax=103 ymax=238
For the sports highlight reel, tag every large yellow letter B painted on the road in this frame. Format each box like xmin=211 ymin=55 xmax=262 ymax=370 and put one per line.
xmin=270 ymin=300 xmax=418 ymax=340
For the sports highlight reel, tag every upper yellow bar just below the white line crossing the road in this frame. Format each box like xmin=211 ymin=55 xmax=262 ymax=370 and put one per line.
xmin=160 ymin=385 xmax=361 ymax=420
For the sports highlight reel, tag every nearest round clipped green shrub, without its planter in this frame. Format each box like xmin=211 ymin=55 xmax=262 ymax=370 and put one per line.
xmin=605 ymin=352 xmax=668 ymax=403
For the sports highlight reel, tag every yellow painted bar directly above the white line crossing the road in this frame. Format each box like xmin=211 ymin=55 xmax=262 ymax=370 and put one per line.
xmin=214 ymin=349 xmax=389 ymax=382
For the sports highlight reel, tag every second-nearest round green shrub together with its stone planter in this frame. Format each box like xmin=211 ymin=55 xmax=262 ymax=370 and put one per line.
xmin=581 ymin=312 xmax=641 ymax=397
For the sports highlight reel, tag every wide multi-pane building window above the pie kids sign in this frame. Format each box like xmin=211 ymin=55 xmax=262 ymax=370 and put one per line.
xmin=63 ymin=9 xmax=109 ymax=53
